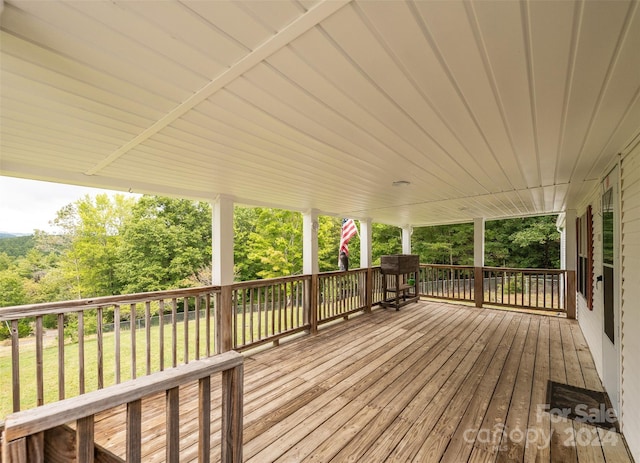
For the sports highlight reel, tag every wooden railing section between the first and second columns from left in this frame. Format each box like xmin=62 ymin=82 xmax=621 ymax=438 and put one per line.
xmin=232 ymin=275 xmax=311 ymax=350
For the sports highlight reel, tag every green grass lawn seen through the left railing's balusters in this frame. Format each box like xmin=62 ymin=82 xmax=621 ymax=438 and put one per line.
xmin=0 ymin=307 xmax=302 ymax=421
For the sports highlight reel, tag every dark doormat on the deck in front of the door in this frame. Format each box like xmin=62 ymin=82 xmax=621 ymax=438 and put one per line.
xmin=547 ymin=381 xmax=620 ymax=433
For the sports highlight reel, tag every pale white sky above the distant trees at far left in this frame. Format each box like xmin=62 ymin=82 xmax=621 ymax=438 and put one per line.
xmin=0 ymin=176 xmax=134 ymax=233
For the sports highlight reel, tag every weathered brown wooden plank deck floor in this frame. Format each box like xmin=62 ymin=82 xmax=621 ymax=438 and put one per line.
xmin=96 ymin=302 xmax=631 ymax=463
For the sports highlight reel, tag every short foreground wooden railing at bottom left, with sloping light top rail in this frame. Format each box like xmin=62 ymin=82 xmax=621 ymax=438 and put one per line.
xmin=3 ymin=351 xmax=243 ymax=463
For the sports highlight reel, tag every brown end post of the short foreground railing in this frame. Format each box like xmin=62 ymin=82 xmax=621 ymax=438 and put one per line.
xmin=220 ymin=365 xmax=244 ymax=463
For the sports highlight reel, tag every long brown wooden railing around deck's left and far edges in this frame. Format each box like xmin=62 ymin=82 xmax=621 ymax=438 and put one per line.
xmin=0 ymin=265 xmax=575 ymax=428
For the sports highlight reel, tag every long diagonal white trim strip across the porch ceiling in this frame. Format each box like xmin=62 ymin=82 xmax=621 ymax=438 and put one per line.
xmin=82 ymin=0 xmax=351 ymax=175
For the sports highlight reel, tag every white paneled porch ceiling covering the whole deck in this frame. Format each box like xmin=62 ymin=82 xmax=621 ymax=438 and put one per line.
xmin=0 ymin=0 xmax=640 ymax=225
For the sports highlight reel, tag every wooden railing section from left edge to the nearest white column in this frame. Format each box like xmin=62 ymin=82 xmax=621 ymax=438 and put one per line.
xmin=0 ymin=286 xmax=219 ymax=411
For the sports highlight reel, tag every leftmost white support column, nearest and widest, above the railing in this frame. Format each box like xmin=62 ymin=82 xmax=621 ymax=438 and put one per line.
xmin=211 ymin=195 xmax=234 ymax=286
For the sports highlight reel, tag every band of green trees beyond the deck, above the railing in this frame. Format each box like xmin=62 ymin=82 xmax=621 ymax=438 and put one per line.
xmin=0 ymin=191 xmax=559 ymax=316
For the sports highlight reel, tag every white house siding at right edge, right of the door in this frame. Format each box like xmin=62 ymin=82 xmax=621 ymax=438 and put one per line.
xmin=621 ymin=145 xmax=640 ymax=461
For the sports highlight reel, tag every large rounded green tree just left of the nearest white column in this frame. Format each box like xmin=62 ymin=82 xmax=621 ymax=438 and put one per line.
xmin=117 ymin=196 xmax=211 ymax=293
